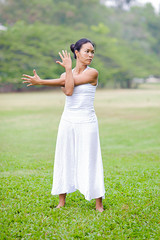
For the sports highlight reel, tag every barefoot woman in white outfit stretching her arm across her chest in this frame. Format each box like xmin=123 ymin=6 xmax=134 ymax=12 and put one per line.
xmin=22 ymin=38 xmax=105 ymax=212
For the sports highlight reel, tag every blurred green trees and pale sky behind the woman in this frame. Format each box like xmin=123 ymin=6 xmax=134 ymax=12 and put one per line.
xmin=0 ymin=0 xmax=160 ymax=92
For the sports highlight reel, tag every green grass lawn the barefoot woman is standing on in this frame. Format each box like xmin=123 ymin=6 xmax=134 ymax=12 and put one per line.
xmin=0 ymin=89 xmax=160 ymax=240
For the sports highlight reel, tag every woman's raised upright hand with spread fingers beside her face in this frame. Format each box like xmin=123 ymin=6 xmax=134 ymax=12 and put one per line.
xmin=56 ymin=50 xmax=72 ymax=70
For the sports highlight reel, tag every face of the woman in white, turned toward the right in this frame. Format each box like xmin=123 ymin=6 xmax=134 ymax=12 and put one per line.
xmin=75 ymin=42 xmax=94 ymax=65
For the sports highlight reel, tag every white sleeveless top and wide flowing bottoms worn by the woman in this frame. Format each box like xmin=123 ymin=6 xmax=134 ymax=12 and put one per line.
xmin=51 ymin=67 xmax=105 ymax=200
